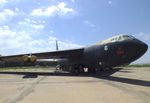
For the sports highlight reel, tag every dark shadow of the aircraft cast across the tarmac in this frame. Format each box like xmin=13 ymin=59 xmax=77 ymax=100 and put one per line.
xmin=0 ymin=68 xmax=150 ymax=87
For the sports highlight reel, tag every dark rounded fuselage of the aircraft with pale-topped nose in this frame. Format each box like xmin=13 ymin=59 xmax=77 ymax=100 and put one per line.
xmin=60 ymin=35 xmax=148 ymax=68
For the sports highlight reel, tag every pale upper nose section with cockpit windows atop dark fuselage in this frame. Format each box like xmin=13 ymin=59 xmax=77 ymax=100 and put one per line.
xmin=98 ymin=35 xmax=134 ymax=44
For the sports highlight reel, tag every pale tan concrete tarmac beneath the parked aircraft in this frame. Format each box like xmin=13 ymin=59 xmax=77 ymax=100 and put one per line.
xmin=0 ymin=67 xmax=150 ymax=103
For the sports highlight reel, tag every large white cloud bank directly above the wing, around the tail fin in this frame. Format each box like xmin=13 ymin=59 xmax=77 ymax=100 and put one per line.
xmin=0 ymin=26 xmax=80 ymax=55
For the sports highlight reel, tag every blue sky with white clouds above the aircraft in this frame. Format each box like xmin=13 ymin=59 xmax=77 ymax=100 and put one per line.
xmin=0 ymin=0 xmax=150 ymax=63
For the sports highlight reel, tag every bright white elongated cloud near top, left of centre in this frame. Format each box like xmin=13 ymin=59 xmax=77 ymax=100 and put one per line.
xmin=31 ymin=2 xmax=74 ymax=16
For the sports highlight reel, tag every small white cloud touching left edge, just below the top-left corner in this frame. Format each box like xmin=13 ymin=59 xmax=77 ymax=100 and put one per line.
xmin=0 ymin=9 xmax=15 ymax=23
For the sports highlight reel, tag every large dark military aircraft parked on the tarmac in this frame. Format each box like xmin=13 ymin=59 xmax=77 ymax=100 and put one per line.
xmin=0 ymin=35 xmax=148 ymax=73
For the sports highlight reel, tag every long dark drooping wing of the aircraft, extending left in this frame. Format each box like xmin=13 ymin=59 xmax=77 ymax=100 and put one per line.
xmin=0 ymin=48 xmax=84 ymax=61
